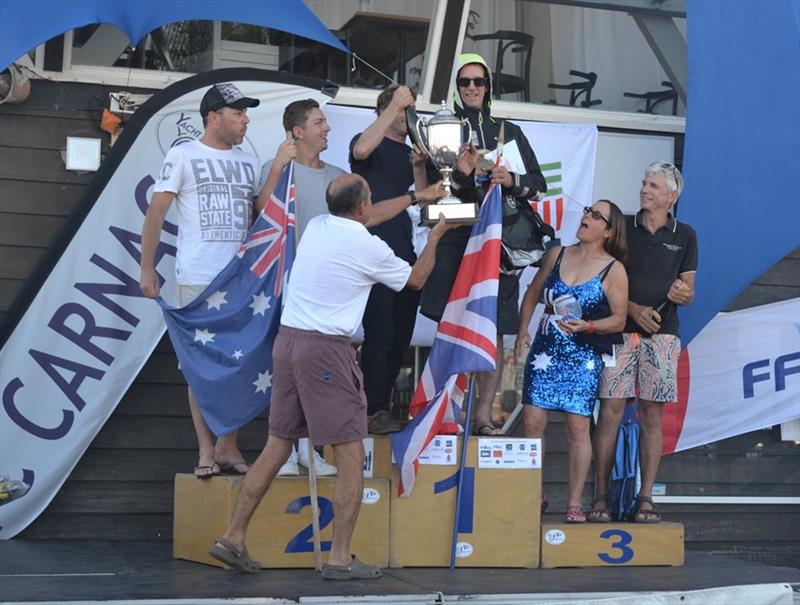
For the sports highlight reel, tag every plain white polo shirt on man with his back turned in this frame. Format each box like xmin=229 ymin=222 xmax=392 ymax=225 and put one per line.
xmin=281 ymin=214 xmax=411 ymax=337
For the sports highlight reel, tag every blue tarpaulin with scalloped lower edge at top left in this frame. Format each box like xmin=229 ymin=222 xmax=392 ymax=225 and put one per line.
xmin=0 ymin=0 xmax=347 ymax=70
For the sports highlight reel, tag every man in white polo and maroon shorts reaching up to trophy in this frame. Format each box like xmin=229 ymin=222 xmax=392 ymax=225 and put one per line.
xmin=209 ymin=174 xmax=449 ymax=580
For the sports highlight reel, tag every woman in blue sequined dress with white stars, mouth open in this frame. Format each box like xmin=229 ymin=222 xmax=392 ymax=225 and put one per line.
xmin=516 ymin=200 xmax=628 ymax=523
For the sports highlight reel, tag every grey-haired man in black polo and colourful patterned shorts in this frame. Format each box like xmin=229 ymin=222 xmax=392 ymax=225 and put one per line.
xmin=588 ymin=162 xmax=697 ymax=523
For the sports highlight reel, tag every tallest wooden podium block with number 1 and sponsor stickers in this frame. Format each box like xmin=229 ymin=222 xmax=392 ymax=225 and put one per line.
xmin=389 ymin=436 xmax=542 ymax=567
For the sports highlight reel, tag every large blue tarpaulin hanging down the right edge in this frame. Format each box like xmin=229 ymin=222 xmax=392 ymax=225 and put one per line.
xmin=678 ymin=0 xmax=800 ymax=346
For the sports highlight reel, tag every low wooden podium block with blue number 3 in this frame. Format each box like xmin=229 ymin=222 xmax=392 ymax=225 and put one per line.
xmin=542 ymin=522 xmax=683 ymax=568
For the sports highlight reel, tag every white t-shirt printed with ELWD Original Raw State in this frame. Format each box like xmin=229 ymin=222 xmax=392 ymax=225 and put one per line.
xmin=154 ymin=141 xmax=259 ymax=285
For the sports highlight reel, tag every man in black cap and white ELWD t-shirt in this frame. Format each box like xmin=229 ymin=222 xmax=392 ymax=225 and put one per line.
xmin=139 ymin=83 xmax=259 ymax=479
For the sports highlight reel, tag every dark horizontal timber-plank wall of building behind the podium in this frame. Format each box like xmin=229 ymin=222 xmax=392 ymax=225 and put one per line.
xmin=0 ymin=80 xmax=800 ymax=562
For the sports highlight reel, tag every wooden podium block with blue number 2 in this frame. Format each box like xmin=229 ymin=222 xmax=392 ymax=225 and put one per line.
xmin=172 ymin=474 xmax=390 ymax=568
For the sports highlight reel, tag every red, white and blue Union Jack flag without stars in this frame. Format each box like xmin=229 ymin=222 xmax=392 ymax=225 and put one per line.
xmin=392 ymin=186 xmax=502 ymax=496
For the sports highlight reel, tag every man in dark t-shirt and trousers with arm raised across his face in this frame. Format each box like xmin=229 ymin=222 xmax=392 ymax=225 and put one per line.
xmin=350 ymin=86 xmax=428 ymax=434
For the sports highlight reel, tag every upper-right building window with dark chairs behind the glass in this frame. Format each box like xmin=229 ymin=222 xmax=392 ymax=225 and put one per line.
xmin=462 ymin=0 xmax=686 ymax=116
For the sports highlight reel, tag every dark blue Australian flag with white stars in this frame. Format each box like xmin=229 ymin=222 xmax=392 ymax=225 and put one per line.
xmin=158 ymin=162 xmax=295 ymax=435
